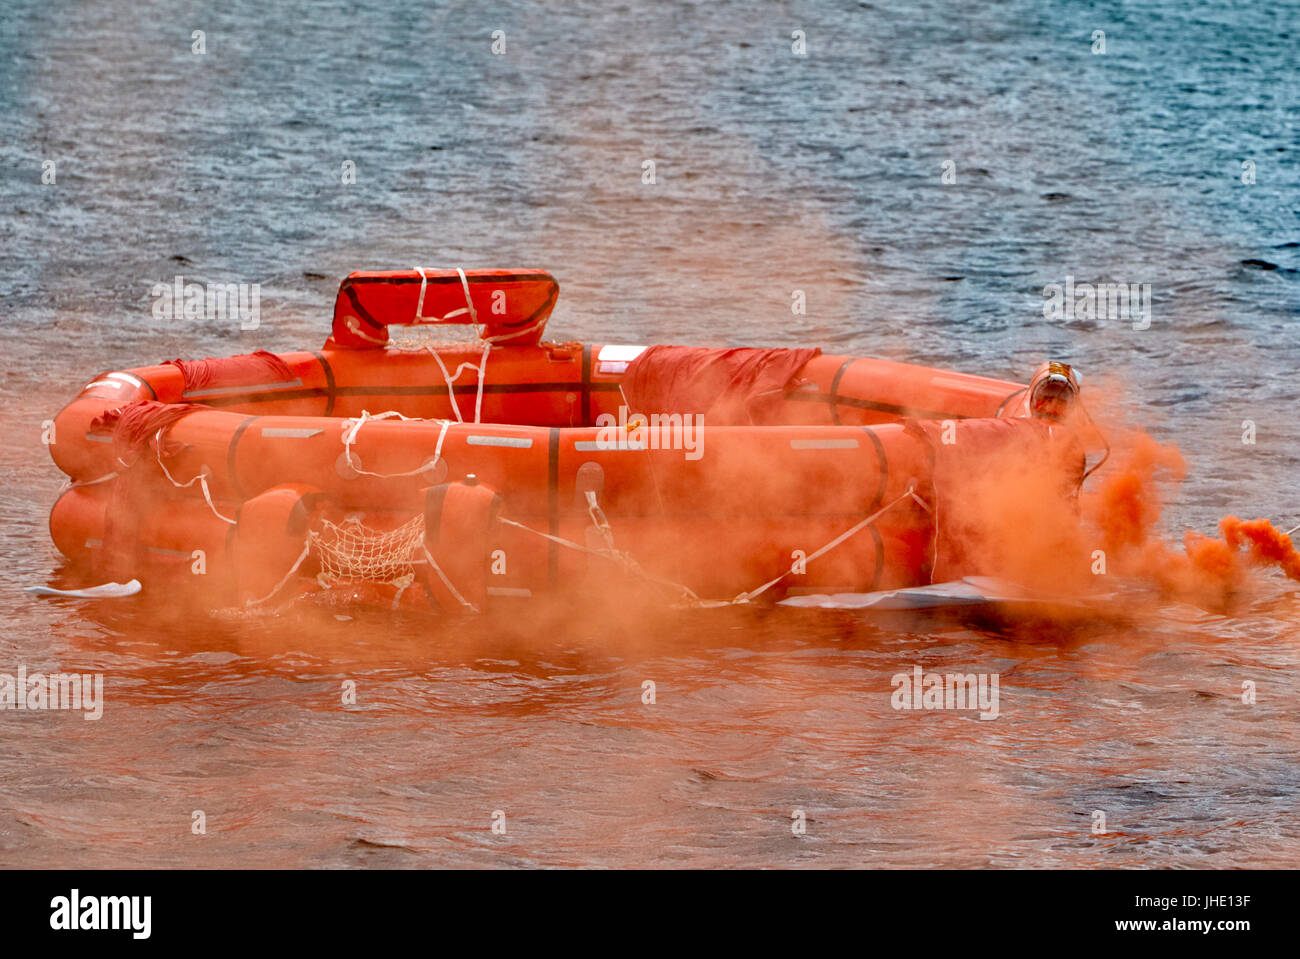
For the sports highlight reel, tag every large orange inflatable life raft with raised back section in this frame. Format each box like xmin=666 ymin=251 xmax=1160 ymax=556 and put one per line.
xmin=49 ymin=269 xmax=1076 ymax=611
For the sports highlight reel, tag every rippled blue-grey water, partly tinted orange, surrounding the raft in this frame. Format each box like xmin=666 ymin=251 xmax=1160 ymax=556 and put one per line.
xmin=0 ymin=0 xmax=1300 ymax=867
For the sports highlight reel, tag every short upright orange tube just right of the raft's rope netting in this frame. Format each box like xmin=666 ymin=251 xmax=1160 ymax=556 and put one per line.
xmin=420 ymin=474 xmax=504 ymax=611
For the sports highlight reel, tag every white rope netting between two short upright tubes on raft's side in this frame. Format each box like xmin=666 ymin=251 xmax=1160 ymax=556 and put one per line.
xmin=308 ymin=516 xmax=424 ymax=590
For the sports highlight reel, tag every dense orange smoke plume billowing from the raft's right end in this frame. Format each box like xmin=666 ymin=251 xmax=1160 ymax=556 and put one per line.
xmin=935 ymin=421 xmax=1300 ymax=611
